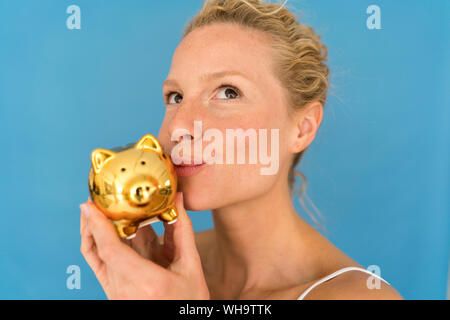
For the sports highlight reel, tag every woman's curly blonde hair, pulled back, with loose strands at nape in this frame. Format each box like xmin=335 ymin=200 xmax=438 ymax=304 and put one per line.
xmin=182 ymin=0 xmax=329 ymax=230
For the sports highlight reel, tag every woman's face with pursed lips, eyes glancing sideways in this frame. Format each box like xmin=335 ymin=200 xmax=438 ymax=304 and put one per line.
xmin=159 ymin=24 xmax=293 ymax=210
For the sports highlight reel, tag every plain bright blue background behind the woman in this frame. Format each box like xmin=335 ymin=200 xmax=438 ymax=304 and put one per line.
xmin=0 ymin=0 xmax=450 ymax=299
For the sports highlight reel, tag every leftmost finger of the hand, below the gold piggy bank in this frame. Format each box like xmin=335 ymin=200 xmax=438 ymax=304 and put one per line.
xmin=81 ymin=203 xmax=164 ymax=276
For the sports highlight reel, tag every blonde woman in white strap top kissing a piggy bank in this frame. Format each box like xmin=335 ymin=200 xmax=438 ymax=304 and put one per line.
xmin=81 ymin=0 xmax=401 ymax=299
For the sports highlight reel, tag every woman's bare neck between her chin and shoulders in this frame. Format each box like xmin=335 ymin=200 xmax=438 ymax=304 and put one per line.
xmin=209 ymin=175 xmax=314 ymax=296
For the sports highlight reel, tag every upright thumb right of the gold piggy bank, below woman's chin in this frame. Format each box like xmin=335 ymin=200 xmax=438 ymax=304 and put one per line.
xmin=164 ymin=192 xmax=199 ymax=263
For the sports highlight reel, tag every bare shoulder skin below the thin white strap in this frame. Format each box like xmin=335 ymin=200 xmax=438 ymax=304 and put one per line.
xmin=305 ymin=271 xmax=403 ymax=300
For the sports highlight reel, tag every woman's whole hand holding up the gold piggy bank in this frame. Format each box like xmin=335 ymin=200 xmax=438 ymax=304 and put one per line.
xmin=80 ymin=192 xmax=210 ymax=299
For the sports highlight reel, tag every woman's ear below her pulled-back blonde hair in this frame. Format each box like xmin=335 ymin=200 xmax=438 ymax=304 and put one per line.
xmin=291 ymin=101 xmax=323 ymax=153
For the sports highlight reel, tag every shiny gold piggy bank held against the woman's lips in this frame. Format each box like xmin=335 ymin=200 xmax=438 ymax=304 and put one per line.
xmin=89 ymin=134 xmax=178 ymax=238
